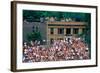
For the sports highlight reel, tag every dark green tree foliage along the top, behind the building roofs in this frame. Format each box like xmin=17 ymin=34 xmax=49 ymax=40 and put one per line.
xmin=23 ymin=10 xmax=88 ymax=22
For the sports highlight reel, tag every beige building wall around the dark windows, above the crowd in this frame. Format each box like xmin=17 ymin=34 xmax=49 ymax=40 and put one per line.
xmin=47 ymin=26 xmax=85 ymax=42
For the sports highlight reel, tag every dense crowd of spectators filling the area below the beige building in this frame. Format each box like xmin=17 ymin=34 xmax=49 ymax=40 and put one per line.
xmin=23 ymin=37 xmax=90 ymax=63
